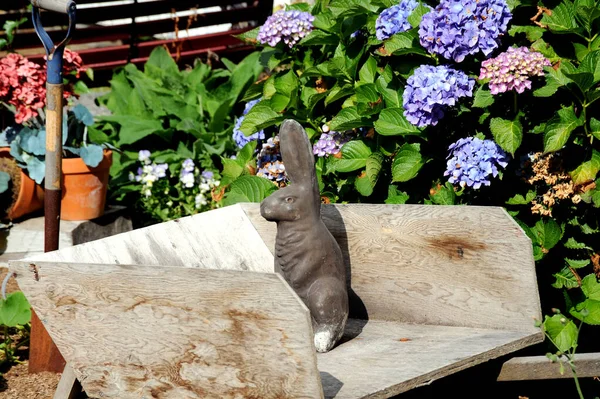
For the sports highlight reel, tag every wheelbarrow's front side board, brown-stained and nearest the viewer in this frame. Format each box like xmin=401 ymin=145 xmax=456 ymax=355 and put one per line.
xmin=11 ymin=262 xmax=322 ymax=399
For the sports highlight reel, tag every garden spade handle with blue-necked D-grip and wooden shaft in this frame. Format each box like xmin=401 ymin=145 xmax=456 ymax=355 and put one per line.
xmin=31 ymin=0 xmax=77 ymax=252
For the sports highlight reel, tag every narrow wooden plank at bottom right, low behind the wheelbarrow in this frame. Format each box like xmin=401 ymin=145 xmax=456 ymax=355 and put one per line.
xmin=498 ymin=353 xmax=600 ymax=381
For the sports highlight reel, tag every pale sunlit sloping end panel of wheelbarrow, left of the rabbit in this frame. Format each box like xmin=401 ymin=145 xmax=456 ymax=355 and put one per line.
xmin=27 ymin=206 xmax=273 ymax=272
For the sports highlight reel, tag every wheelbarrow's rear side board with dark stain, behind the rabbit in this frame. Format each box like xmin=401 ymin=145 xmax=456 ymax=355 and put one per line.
xmin=242 ymin=204 xmax=541 ymax=333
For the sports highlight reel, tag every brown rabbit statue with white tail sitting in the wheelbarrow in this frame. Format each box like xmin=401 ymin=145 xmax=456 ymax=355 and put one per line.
xmin=260 ymin=120 xmax=348 ymax=352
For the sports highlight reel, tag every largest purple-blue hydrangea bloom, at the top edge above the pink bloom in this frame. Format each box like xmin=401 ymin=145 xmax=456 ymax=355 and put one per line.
xmin=419 ymin=0 xmax=512 ymax=62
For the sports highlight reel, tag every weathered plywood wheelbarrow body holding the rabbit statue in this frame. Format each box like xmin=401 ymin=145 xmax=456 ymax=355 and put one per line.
xmin=11 ymin=204 xmax=543 ymax=399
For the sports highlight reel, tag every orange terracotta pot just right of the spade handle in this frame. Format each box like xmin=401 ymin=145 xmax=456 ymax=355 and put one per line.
xmin=60 ymin=150 xmax=112 ymax=220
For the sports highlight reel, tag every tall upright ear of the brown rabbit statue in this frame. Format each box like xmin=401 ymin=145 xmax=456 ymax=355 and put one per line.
xmin=279 ymin=119 xmax=318 ymax=187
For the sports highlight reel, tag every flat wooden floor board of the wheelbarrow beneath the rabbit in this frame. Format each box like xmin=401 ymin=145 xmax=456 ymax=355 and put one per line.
xmin=317 ymin=319 xmax=539 ymax=399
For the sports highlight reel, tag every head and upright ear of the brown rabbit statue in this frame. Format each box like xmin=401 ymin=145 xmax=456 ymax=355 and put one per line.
xmin=260 ymin=119 xmax=321 ymax=222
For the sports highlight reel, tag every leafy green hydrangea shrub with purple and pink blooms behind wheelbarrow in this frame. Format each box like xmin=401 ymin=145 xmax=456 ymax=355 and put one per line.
xmin=226 ymin=0 xmax=600 ymax=388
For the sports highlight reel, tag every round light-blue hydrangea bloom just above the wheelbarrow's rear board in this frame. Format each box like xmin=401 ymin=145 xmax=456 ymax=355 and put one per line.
xmin=444 ymin=137 xmax=508 ymax=190
